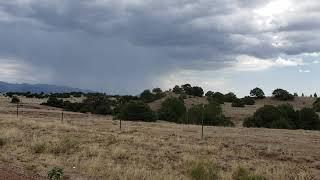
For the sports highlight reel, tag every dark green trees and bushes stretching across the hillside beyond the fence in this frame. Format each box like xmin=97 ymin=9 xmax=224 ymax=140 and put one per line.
xmin=7 ymin=84 xmax=320 ymax=129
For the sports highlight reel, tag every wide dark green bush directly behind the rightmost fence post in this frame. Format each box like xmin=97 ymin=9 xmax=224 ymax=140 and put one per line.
xmin=184 ymin=103 xmax=234 ymax=126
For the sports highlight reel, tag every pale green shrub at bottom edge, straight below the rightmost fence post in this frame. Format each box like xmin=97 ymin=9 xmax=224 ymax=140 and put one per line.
xmin=189 ymin=162 xmax=220 ymax=180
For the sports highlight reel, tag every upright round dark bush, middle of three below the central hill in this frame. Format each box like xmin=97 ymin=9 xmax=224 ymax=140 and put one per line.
xmin=158 ymin=97 xmax=186 ymax=122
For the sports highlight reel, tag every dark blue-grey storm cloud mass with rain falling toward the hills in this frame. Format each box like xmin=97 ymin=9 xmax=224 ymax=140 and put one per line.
xmin=0 ymin=0 xmax=320 ymax=92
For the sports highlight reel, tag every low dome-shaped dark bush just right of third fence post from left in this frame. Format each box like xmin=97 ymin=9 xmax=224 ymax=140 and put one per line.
xmin=117 ymin=101 xmax=155 ymax=122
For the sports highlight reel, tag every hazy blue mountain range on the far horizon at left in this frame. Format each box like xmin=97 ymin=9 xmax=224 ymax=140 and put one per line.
xmin=0 ymin=81 xmax=94 ymax=93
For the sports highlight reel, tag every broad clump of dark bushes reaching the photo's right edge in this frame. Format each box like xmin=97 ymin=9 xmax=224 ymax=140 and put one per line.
xmin=243 ymin=105 xmax=320 ymax=130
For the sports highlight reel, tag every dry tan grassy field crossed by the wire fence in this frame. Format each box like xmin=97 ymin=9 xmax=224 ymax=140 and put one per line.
xmin=0 ymin=97 xmax=320 ymax=180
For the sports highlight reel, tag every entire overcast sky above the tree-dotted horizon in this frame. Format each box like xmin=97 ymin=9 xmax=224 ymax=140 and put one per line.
xmin=0 ymin=0 xmax=320 ymax=96
